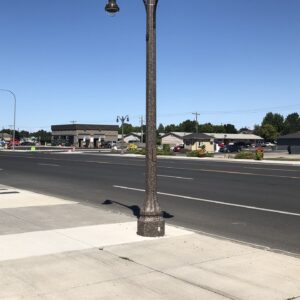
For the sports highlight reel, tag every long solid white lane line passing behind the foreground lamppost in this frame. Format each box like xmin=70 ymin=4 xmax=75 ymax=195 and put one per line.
xmin=113 ymin=185 xmax=300 ymax=217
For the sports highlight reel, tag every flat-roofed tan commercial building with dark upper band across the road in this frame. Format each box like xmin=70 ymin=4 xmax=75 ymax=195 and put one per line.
xmin=51 ymin=124 xmax=119 ymax=148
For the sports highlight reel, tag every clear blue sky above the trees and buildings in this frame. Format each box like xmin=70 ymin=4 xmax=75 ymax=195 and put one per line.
xmin=0 ymin=0 xmax=300 ymax=132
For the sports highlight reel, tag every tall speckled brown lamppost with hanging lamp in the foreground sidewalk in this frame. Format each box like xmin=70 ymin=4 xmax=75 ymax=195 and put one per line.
xmin=105 ymin=0 xmax=165 ymax=237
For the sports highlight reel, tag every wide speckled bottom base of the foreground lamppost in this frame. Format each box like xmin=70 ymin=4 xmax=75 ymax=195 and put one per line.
xmin=137 ymin=214 xmax=165 ymax=237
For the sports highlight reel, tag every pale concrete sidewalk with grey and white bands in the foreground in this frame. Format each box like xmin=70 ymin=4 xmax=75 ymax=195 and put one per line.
xmin=0 ymin=185 xmax=300 ymax=300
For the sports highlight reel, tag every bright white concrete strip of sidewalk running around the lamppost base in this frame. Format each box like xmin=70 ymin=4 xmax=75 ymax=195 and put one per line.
xmin=0 ymin=222 xmax=193 ymax=261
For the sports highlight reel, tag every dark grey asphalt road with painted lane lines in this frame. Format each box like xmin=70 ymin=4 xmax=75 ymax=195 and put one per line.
xmin=0 ymin=152 xmax=300 ymax=255
